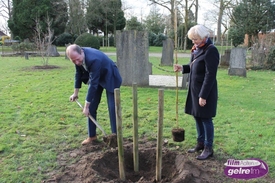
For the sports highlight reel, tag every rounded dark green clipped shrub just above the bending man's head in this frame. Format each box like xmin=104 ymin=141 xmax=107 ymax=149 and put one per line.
xmin=74 ymin=33 xmax=100 ymax=49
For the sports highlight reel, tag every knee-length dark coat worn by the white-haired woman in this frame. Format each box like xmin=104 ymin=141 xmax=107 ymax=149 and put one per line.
xmin=182 ymin=39 xmax=219 ymax=118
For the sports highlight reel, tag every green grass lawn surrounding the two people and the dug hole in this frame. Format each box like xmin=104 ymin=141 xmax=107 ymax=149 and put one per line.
xmin=0 ymin=53 xmax=275 ymax=182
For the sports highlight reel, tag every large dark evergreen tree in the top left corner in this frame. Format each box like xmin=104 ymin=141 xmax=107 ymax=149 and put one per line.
xmin=8 ymin=0 xmax=67 ymax=40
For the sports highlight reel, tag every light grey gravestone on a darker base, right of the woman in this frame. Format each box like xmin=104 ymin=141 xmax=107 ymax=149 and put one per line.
xmin=228 ymin=48 xmax=246 ymax=77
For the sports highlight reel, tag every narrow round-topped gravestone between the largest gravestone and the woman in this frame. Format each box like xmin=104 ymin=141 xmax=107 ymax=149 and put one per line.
xmin=161 ymin=38 xmax=174 ymax=66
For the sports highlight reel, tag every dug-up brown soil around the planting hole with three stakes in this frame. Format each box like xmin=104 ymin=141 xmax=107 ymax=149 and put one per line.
xmin=44 ymin=139 xmax=272 ymax=183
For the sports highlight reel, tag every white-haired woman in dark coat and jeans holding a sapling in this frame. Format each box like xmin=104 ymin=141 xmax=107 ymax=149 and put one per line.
xmin=174 ymin=25 xmax=219 ymax=160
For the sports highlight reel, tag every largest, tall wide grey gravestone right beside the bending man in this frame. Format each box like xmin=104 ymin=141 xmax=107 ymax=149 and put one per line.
xmin=116 ymin=30 xmax=152 ymax=86
